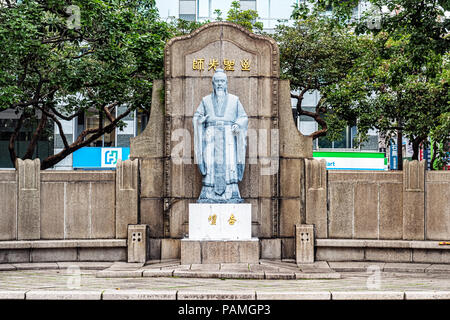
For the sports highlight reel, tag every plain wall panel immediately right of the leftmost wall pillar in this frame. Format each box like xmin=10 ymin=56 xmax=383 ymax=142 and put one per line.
xmin=41 ymin=182 xmax=65 ymax=239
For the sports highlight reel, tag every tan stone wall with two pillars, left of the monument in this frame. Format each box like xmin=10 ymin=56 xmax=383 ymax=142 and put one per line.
xmin=0 ymin=159 xmax=138 ymax=240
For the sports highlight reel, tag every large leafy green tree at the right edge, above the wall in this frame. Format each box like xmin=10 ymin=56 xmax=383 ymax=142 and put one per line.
xmin=329 ymin=0 xmax=450 ymax=170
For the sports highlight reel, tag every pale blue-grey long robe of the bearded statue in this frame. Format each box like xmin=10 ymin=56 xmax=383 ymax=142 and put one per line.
xmin=193 ymin=93 xmax=248 ymax=203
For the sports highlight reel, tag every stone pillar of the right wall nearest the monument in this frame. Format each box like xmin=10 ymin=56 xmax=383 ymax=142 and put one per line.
xmin=305 ymin=159 xmax=328 ymax=238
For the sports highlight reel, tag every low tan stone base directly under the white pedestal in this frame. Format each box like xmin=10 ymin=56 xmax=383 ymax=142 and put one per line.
xmin=181 ymin=238 xmax=259 ymax=264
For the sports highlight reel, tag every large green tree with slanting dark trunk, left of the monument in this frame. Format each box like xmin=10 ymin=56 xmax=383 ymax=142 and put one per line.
xmin=0 ymin=0 xmax=170 ymax=169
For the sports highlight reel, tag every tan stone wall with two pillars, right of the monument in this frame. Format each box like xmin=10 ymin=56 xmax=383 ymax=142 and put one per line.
xmin=305 ymin=160 xmax=450 ymax=241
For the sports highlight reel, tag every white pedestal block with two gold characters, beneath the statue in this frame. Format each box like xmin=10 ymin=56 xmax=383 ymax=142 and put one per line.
xmin=189 ymin=203 xmax=252 ymax=240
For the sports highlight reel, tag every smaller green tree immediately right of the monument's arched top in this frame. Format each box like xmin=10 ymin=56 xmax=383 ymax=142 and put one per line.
xmin=274 ymin=12 xmax=367 ymax=140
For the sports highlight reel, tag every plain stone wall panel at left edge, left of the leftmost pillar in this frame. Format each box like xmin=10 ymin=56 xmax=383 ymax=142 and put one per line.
xmin=0 ymin=181 xmax=17 ymax=240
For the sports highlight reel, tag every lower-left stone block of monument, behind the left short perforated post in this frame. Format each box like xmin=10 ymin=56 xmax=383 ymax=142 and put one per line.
xmin=140 ymin=198 xmax=164 ymax=238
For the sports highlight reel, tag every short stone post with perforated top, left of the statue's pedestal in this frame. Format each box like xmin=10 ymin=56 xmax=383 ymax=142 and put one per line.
xmin=127 ymin=224 xmax=150 ymax=263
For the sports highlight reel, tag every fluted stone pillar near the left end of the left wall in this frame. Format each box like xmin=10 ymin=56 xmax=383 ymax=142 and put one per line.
xmin=16 ymin=159 xmax=41 ymax=240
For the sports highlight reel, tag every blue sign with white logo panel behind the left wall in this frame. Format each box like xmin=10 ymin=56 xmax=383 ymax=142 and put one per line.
xmin=73 ymin=147 xmax=130 ymax=169
